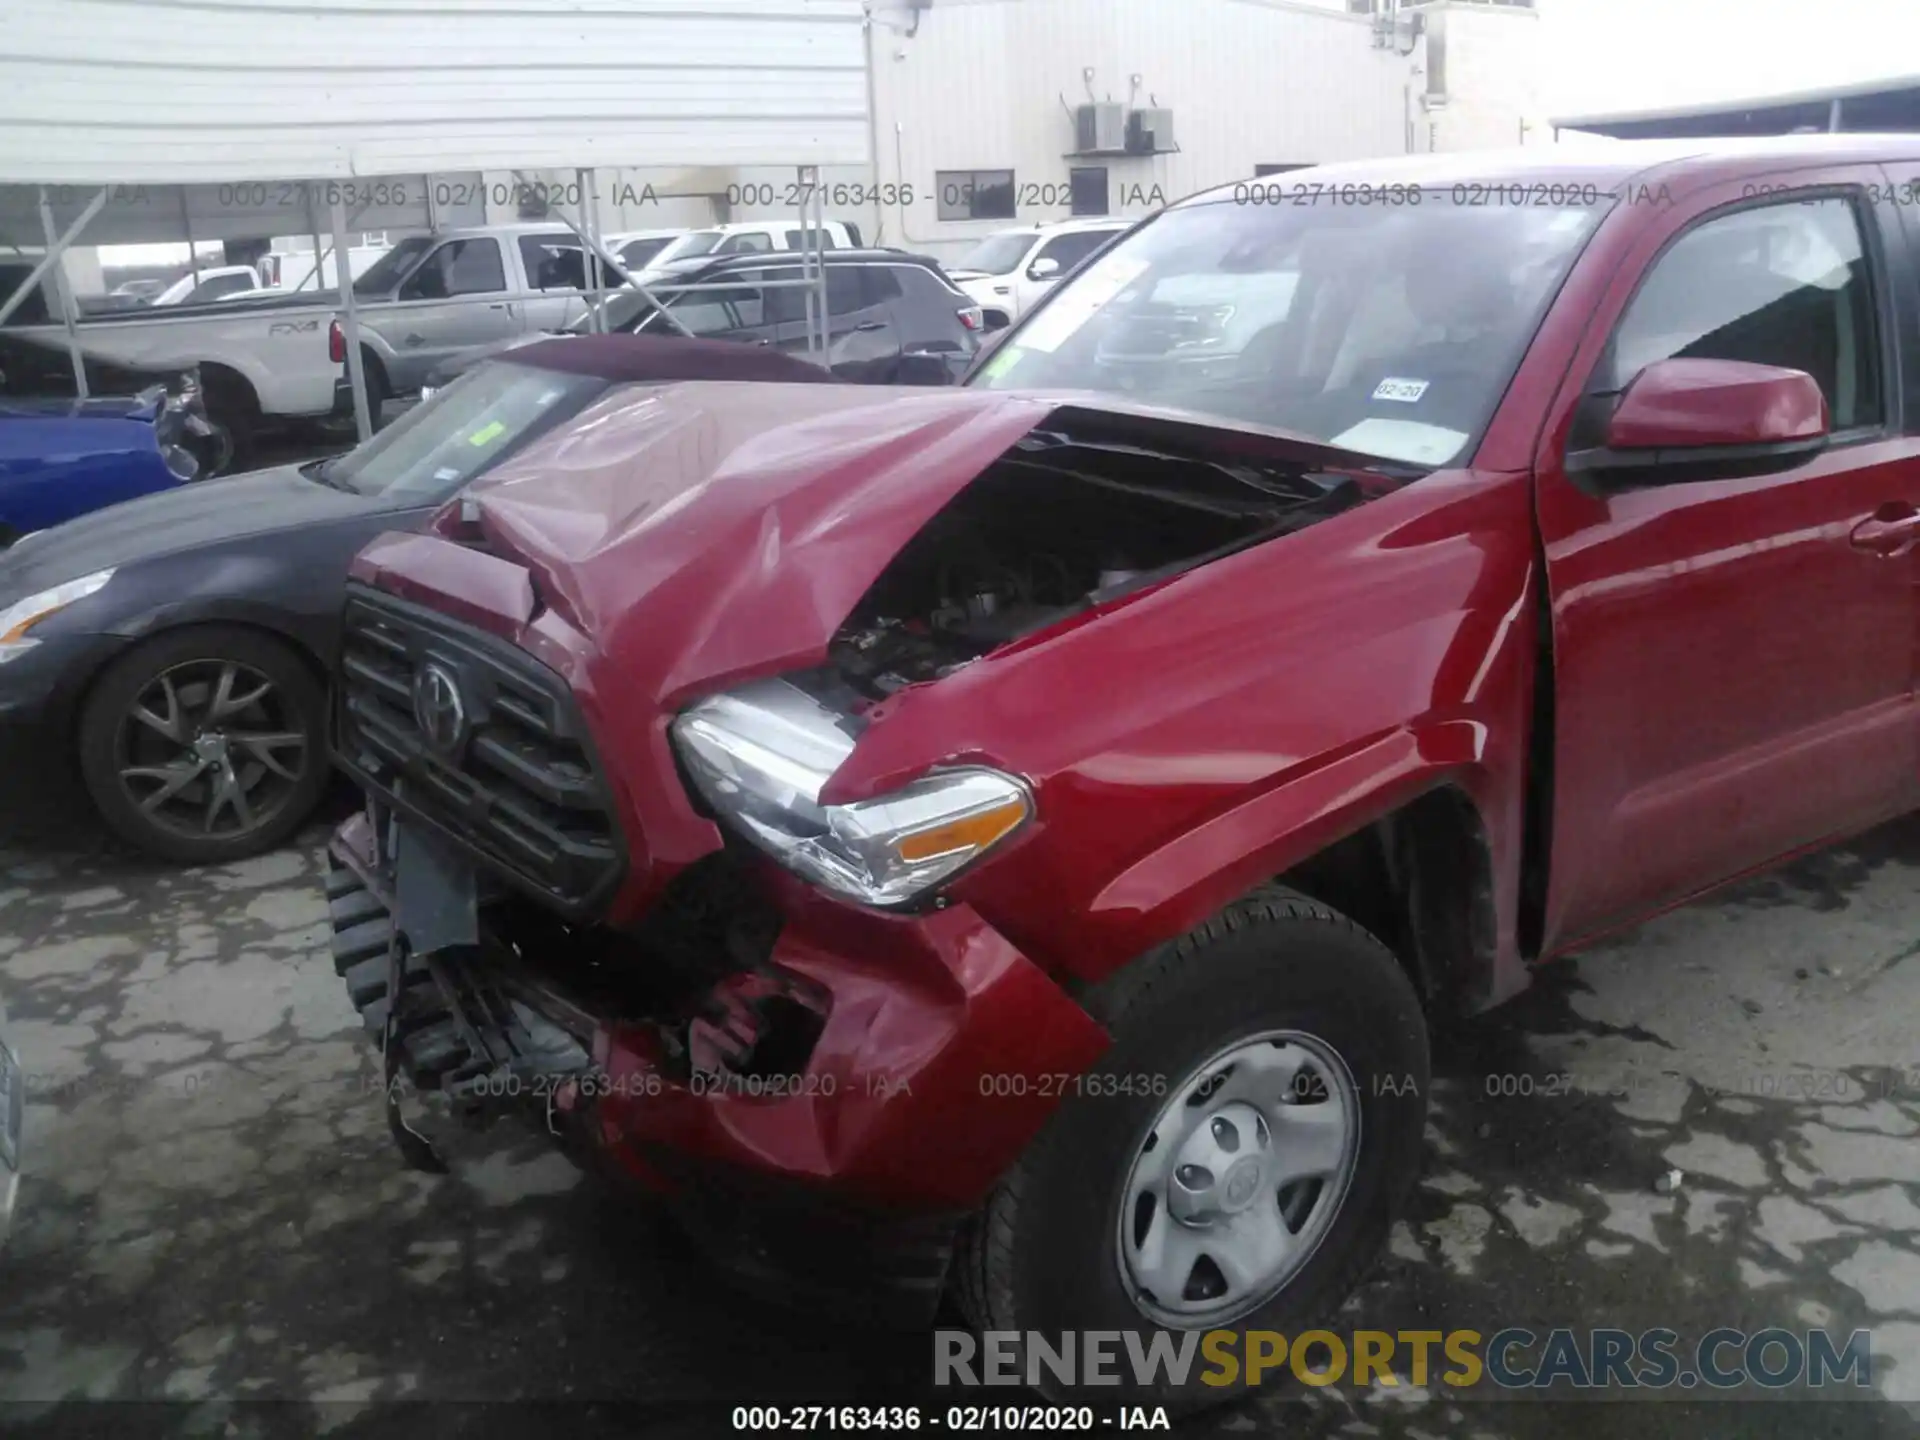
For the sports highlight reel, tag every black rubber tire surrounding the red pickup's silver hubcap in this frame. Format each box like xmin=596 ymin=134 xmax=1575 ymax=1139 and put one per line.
xmin=954 ymin=887 xmax=1428 ymax=1411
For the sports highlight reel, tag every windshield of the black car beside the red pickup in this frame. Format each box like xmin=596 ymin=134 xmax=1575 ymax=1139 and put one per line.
xmin=323 ymin=361 xmax=612 ymax=505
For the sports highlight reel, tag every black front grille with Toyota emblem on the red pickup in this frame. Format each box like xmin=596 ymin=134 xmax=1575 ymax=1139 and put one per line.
xmin=336 ymin=586 xmax=624 ymax=916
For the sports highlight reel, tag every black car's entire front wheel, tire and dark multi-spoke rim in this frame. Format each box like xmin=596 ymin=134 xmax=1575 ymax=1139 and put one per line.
xmin=79 ymin=626 xmax=328 ymax=864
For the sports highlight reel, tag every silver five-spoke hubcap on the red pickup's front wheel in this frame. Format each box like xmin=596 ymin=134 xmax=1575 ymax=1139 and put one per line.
xmin=1117 ymin=1031 xmax=1359 ymax=1329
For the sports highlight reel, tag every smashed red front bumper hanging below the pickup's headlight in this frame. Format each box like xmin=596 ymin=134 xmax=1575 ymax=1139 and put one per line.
xmin=328 ymin=814 xmax=1108 ymax=1323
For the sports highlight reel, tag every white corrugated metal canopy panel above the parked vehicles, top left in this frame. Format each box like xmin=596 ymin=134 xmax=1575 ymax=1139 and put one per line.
xmin=0 ymin=0 xmax=868 ymax=184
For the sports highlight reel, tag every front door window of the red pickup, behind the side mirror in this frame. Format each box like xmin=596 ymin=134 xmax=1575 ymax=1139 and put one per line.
xmin=1594 ymin=198 xmax=1885 ymax=432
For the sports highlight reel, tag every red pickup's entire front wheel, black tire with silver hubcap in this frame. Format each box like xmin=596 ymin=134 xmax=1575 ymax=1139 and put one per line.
xmin=958 ymin=889 xmax=1428 ymax=1407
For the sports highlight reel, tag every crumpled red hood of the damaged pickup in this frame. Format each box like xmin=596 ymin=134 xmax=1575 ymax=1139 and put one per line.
xmin=430 ymin=382 xmax=1052 ymax=705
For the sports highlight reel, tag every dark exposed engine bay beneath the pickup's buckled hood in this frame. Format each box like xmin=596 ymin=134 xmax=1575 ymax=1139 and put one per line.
xmin=829 ymin=415 xmax=1369 ymax=699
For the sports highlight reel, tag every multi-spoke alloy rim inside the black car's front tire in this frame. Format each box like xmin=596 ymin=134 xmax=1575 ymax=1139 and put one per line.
xmin=115 ymin=659 xmax=315 ymax=839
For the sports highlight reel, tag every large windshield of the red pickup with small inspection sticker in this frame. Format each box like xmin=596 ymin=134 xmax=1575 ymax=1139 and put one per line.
xmin=972 ymin=186 xmax=1611 ymax=468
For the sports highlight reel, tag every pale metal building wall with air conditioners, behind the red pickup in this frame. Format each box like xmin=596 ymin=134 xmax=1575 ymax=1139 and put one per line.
xmin=874 ymin=0 xmax=1425 ymax=252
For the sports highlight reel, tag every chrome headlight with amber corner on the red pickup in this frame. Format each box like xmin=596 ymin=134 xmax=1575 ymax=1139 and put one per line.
xmin=674 ymin=680 xmax=1033 ymax=906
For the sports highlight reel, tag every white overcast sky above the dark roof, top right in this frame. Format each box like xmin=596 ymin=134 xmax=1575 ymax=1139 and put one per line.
xmin=1540 ymin=0 xmax=1920 ymax=115
